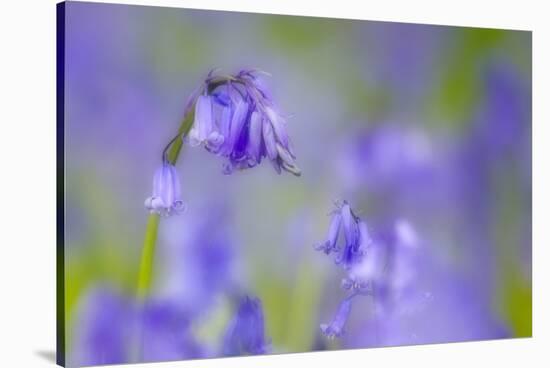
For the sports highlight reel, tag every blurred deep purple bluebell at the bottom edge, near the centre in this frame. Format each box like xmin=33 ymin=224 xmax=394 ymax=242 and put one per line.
xmin=223 ymin=296 xmax=269 ymax=355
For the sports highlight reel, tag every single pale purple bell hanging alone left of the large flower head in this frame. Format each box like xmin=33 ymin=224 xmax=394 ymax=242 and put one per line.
xmin=145 ymin=160 xmax=185 ymax=216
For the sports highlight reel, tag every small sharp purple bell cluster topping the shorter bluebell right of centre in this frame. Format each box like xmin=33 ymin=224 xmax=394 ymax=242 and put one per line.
xmin=314 ymin=201 xmax=371 ymax=269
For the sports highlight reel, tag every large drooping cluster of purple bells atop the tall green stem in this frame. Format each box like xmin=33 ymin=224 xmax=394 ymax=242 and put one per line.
xmin=188 ymin=70 xmax=301 ymax=176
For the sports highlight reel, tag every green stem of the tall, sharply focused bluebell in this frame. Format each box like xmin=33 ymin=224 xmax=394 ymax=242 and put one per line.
xmin=137 ymin=104 xmax=195 ymax=301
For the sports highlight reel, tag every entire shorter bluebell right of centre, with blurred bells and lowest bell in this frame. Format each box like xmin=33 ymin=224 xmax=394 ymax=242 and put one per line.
xmin=315 ymin=201 xmax=419 ymax=338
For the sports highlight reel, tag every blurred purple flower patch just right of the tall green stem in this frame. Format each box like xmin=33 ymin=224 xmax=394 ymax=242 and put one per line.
xmin=159 ymin=202 xmax=236 ymax=316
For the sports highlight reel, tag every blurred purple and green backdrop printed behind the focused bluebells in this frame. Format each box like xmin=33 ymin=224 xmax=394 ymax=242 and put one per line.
xmin=65 ymin=3 xmax=531 ymax=364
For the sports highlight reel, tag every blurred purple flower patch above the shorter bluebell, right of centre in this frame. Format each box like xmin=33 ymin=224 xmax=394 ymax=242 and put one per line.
xmin=334 ymin=122 xmax=445 ymax=202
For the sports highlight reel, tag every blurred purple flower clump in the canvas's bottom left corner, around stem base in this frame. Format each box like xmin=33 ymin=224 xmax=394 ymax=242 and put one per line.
xmin=70 ymin=288 xmax=204 ymax=366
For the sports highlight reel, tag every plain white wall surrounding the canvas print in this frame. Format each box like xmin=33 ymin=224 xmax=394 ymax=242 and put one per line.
xmin=0 ymin=0 xmax=550 ymax=368
